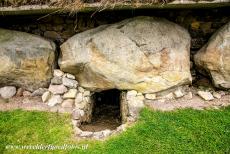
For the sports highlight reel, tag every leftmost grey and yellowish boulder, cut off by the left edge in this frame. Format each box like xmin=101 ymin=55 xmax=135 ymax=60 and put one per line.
xmin=0 ymin=29 xmax=55 ymax=91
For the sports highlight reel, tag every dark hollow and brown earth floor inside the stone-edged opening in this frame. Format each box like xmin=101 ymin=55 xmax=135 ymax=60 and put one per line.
xmin=80 ymin=89 xmax=121 ymax=132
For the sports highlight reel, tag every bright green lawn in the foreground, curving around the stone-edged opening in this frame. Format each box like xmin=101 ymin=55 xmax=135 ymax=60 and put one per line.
xmin=0 ymin=108 xmax=230 ymax=154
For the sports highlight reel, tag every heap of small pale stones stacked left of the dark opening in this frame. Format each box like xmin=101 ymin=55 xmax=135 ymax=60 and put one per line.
xmin=41 ymin=69 xmax=91 ymax=116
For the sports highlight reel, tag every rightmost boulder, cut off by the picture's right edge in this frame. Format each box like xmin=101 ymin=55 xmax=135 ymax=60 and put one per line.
xmin=194 ymin=22 xmax=230 ymax=88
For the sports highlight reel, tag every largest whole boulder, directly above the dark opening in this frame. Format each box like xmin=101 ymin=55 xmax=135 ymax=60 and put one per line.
xmin=59 ymin=17 xmax=191 ymax=93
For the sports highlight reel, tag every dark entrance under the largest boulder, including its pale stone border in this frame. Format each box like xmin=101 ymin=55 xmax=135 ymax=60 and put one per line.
xmin=72 ymin=89 xmax=133 ymax=139
